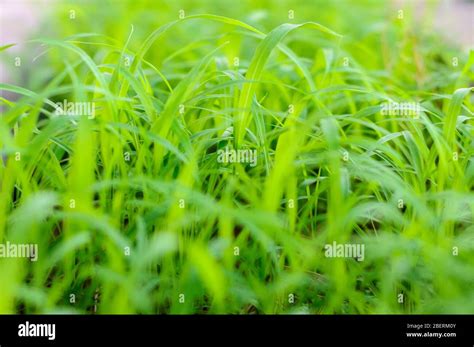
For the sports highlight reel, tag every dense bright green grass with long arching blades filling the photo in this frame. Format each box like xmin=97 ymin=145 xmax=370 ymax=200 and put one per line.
xmin=0 ymin=0 xmax=474 ymax=314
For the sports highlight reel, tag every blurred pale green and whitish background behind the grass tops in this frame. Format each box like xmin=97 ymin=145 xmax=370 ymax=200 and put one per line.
xmin=0 ymin=0 xmax=474 ymax=87
